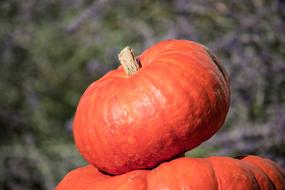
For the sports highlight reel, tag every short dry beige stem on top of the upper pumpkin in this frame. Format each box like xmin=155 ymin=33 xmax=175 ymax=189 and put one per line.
xmin=118 ymin=46 xmax=141 ymax=76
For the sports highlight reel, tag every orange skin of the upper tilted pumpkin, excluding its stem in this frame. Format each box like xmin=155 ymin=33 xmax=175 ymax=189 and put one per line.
xmin=73 ymin=40 xmax=230 ymax=175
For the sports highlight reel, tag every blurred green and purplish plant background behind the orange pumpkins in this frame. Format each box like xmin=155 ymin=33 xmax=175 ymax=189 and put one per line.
xmin=0 ymin=0 xmax=285 ymax=190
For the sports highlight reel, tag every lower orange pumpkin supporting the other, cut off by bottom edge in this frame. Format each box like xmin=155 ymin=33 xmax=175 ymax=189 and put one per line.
xmin=56 ymin=156 xmax=285 ymax=190
